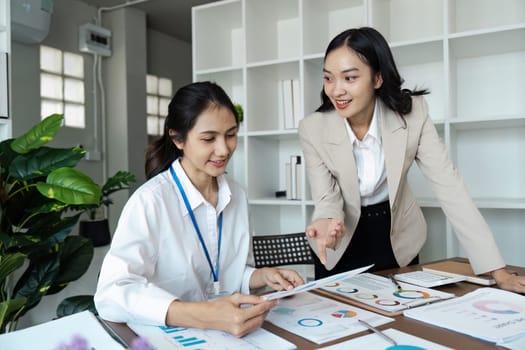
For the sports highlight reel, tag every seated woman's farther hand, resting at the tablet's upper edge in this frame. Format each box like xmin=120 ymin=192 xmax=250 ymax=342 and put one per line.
xmin=250 ymin=267 xmax=304 ymax=290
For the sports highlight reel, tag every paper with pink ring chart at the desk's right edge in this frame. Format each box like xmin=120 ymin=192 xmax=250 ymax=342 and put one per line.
xmin=403 ymin=287 xmax=525 ymax=344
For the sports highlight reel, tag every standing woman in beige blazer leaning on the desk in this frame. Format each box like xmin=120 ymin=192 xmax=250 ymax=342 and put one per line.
xmin=299 ymin=27 xmax=525 ymax=292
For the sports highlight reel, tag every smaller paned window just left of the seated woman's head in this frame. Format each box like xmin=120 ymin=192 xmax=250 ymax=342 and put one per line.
xmin=146 ymin=74 xmax=173 ymax=136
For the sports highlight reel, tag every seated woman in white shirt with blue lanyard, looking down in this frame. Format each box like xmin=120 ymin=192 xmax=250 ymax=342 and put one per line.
xmin=95 ymin=82 xmax=303 ymax=336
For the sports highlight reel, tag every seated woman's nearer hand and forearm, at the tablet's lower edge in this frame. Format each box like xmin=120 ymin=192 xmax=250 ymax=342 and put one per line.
xmin=166 ymin=293 xmax=277 ymax=338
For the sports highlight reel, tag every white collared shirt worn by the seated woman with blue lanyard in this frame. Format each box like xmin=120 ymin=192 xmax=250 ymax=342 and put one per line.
xmin=95 ymin=160 xmax=254 ymax=325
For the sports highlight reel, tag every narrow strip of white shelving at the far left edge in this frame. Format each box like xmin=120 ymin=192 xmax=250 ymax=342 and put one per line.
xmin=0 ymin=0 xmax=11 ymax=141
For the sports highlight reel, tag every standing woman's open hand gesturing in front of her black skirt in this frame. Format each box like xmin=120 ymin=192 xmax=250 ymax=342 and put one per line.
xmin=306 ymin=219 xmax=345 ymax=265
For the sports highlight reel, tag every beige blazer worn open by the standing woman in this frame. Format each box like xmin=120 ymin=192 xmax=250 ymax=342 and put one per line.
xmin=299 ymin=97 xmax=505 ymax=273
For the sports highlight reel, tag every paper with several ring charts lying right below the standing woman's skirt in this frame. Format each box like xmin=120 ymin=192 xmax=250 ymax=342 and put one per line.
xmin=320 ymin=272 xmax=454 ymax=316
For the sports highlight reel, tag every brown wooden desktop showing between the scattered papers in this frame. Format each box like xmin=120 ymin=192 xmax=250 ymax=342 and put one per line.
xmin=106 ymin=258 xmax=525 ymax=350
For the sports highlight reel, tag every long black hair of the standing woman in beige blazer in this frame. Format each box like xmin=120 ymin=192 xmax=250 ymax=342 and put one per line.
xmin=317 ymin=27 xmax=429 ymax=115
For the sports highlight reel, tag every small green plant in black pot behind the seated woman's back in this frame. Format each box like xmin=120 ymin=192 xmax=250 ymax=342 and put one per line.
xmin=79 ymin=170 xmax=137 ymax=247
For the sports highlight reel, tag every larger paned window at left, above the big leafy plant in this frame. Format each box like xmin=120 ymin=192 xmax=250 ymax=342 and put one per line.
xmin=40 ymin=46 xmax=86 ymax=129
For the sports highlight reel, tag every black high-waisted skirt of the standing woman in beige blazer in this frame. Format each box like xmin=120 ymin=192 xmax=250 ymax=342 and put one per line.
xmin=314 ymin=201 xmax=419 ymax=279
